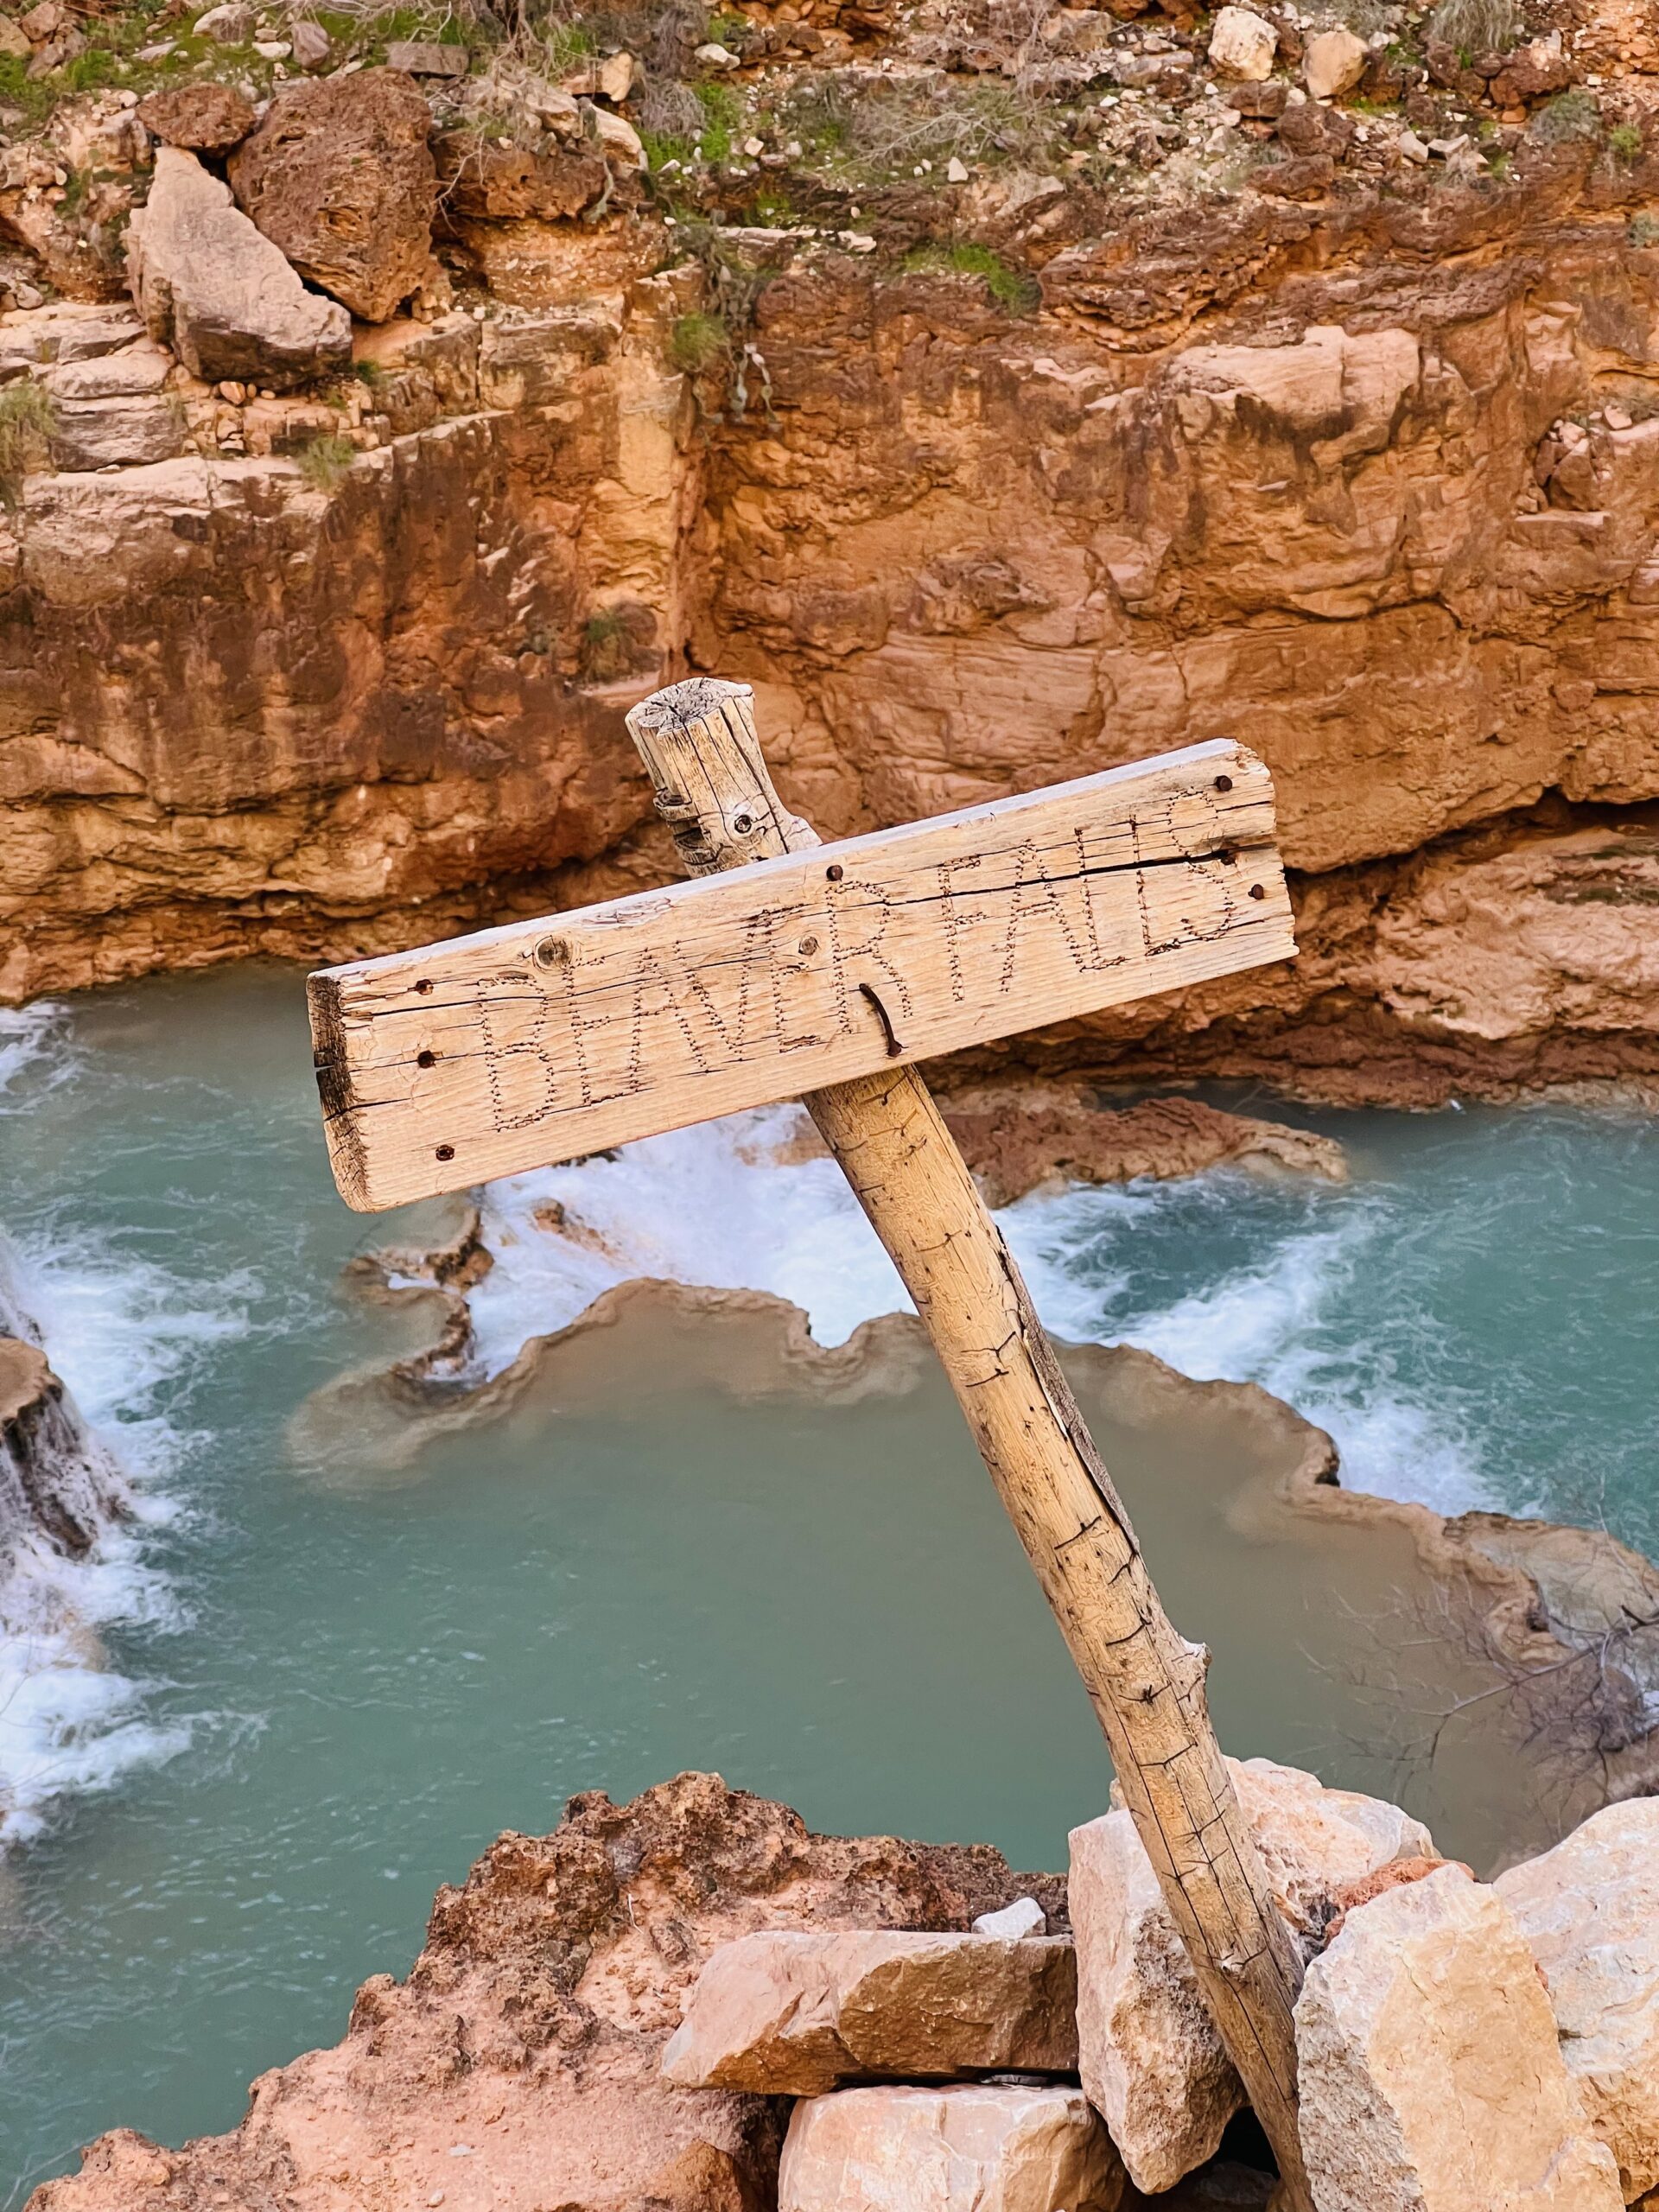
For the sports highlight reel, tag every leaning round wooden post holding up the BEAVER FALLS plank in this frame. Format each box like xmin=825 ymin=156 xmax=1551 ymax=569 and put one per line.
xmin=628 ymin=677 xmax=1312 ymax=2212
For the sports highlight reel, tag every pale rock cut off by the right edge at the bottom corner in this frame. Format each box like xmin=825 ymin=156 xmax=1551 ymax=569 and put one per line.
xmin=1493 ymin=1798 xmax=1659 ymax=2203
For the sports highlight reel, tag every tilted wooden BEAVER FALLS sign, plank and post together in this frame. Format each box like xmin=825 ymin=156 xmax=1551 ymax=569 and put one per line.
xmin=309 ymin=677 xmax=1312 ymax=2212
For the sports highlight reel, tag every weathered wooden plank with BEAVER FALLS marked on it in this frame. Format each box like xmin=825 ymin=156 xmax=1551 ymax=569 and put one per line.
xmin=309 ymin=743 xmax=1294 ymax=1210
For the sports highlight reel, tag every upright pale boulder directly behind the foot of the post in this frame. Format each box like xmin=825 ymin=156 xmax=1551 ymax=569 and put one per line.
xmin=1071 ymin=1758 xmax=1433 ymax=2195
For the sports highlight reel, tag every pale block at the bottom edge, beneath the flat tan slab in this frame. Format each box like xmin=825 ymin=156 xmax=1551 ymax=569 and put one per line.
xmin=779 ymin=2086 xmax=1123 ymax=2212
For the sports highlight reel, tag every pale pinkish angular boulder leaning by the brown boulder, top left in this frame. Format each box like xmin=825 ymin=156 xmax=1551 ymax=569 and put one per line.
xmin=126 ymin=146 xmax=352 ymax=390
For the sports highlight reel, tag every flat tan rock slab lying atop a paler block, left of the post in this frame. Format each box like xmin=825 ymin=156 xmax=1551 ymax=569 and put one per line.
xmin=664 ymin=1929 xmax=1077 ymax=2097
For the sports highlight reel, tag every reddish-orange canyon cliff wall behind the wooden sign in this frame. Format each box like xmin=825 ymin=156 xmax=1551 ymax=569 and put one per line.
xmin=0 ymin=123 xmax=1659 ymax=1102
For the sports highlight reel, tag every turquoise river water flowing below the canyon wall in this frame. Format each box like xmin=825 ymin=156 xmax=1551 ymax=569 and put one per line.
xmin=0 ymin=969 xmax=1659 ymax=2208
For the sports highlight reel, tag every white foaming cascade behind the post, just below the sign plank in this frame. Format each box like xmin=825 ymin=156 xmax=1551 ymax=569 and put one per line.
xmin=471 ymin=1106 xmax=1491 ymax=1513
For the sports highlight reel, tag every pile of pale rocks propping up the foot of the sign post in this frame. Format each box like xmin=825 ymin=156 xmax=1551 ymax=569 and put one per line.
xmin=664 ymin=1761 xmax=1659 ymax=2212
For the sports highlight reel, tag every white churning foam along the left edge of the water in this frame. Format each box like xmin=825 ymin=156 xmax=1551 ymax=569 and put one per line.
xmin=0 ymin=1007 xmax=241 ymax=1847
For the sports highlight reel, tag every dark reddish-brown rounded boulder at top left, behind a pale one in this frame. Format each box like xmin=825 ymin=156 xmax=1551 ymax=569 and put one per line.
xmin=230 ymin=68 xmax=438 ymax=323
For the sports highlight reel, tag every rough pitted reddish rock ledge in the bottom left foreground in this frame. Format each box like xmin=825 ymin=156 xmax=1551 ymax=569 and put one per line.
xmin=31 ymin=1774 xmax=1064 ymax=2212
